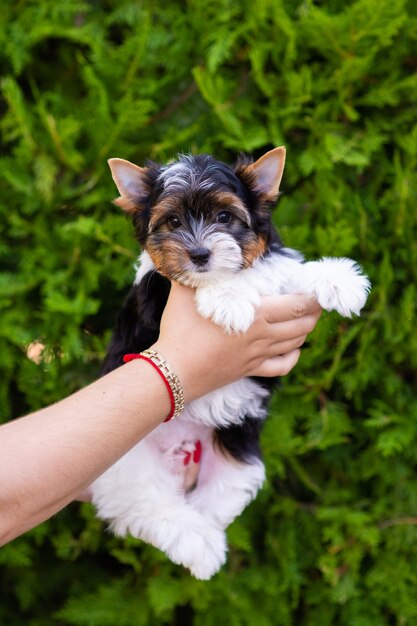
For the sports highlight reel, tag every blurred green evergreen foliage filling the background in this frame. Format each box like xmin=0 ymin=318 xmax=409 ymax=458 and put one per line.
xmin=0 ymin=0 xmax=417 ymax=626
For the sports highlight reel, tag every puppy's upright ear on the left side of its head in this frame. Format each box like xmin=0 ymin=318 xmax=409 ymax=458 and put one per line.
xmin=107 ymin=159 xmax=148 ymax=213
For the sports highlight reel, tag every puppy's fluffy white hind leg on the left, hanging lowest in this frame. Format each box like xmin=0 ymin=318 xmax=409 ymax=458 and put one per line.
xmin=92 ymin=442 xmax=226 ymax=579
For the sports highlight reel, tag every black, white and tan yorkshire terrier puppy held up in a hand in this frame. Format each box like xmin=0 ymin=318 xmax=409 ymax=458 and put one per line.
xmin=92 ymin=147 xmax=370 ymax=579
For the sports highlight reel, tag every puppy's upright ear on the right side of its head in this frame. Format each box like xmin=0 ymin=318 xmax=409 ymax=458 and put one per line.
xmin=247 ymin=146 xmax=286 ymax=200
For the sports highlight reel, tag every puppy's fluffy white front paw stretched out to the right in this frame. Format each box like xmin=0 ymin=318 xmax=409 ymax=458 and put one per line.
xmin=288 ymin=258 xmax=371 ymax=317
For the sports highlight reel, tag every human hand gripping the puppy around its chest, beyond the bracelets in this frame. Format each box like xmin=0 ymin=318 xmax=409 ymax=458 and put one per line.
xmin=153 ymin=283 xmax=321 ymax=401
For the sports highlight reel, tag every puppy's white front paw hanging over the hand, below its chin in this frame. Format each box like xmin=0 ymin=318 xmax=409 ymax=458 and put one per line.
xmin=196 ymin=285 xmax=259 ymax=334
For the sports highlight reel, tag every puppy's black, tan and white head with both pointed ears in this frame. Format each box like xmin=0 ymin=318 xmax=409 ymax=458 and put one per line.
xmin=109 ymin=147 xmax=285 ymax=287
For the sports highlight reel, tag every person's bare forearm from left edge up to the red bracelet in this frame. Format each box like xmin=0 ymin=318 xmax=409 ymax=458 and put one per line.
xmin=0 ymin=361 xmax=169 ymax=544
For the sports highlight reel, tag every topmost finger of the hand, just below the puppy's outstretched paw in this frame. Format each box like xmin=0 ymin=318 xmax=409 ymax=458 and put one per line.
xmin=259 ymin=293 xmax=321 ymax=324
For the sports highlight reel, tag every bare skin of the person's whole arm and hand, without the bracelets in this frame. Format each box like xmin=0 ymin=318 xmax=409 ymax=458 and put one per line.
xmin=0 ymin=284 xmax=321 ymax=545
